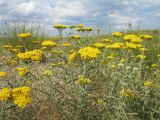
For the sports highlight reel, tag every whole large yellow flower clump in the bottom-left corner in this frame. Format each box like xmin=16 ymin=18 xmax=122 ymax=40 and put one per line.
xmin=0 ymin=86 xmax=32 ymax=108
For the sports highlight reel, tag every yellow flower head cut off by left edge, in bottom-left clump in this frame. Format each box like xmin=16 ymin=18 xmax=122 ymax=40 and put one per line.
xmin=0 ymin=88 xmax=10 ymax=100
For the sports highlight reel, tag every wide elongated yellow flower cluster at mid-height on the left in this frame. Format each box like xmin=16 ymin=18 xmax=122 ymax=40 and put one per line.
xmin=17 ymin=49 xmax=44 ymax=61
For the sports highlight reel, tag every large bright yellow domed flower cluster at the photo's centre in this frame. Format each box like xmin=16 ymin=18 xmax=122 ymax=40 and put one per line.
xmin=78 ymin=47 xmax=101 ymax=60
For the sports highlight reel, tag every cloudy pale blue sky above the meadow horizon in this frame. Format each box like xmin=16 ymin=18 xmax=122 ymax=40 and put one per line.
xmin=0 ymin=0 xmax=160 ymax=34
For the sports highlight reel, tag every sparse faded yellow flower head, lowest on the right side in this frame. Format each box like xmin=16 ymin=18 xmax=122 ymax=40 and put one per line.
xmin=119 ymin=89 xmax=135 ymax=98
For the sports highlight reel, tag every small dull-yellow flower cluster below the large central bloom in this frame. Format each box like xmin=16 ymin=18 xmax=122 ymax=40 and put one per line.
xmin=76 ymin=76 xmax=92 ymax=85
